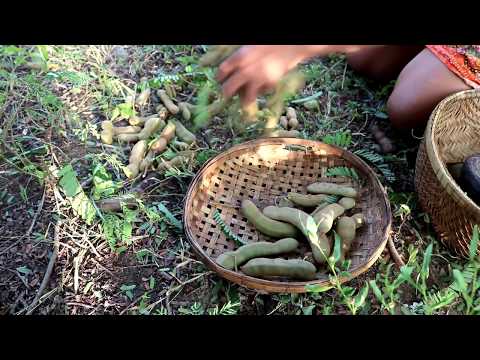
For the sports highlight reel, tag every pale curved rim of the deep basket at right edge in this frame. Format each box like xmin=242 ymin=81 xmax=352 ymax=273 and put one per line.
xmin=424 ymin=89 xmax=480 ymax=216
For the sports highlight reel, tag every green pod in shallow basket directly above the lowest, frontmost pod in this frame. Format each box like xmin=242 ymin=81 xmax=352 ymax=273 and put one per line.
xmin=216 ymin=238 xmax=298 ymax=270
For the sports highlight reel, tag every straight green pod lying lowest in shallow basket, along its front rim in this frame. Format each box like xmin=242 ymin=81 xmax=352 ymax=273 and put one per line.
xmin=241 ymin=258 xmax=317 ymax=280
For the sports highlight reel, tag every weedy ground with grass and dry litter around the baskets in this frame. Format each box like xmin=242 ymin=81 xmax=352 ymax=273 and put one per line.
xmin=0 ymin=46 xmax=480 ymax=315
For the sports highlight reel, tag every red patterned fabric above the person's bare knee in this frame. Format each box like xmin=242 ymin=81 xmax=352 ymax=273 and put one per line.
xmin=427 ymin=45 xmax=480 ymax=88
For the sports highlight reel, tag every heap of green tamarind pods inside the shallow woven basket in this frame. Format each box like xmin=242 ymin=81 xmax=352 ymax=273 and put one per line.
xmin=216 ymin=182 xmax=365 ymax=280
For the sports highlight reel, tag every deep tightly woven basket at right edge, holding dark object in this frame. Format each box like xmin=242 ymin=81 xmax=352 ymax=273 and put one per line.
xmin=415 ymin=90 xmax=480 ymax=256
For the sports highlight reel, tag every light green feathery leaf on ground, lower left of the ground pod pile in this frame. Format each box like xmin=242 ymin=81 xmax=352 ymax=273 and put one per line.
xmin=58 ymin=164 xmax=96 ymax=225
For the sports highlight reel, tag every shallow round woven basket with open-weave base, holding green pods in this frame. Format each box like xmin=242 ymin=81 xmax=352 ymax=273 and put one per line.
xmin=183 ymin=138 xmax=391 ymax=293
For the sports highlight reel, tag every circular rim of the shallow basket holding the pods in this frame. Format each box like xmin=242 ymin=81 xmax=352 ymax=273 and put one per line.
xmin=182 ymin=138 xmax=392 ymax=293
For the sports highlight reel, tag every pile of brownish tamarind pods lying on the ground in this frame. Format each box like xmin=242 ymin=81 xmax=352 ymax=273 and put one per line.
xmin=100 ymin=85 xmax=196 ymax=179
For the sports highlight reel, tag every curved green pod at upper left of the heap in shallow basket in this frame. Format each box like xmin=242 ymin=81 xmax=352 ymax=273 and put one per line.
xmin=241 ymin=199 xmax=299 ymax=238
